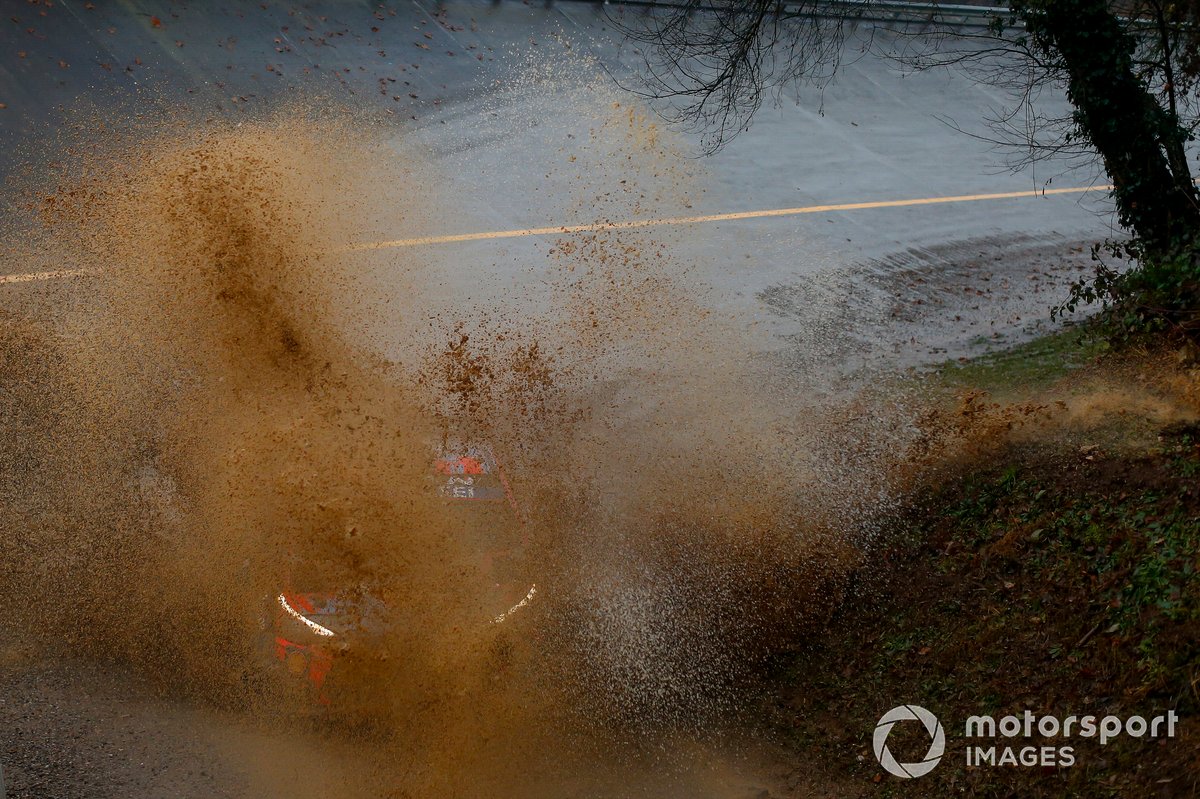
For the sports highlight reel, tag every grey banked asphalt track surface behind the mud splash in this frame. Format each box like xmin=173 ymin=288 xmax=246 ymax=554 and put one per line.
xmin=0 ymin=0 xmax=1114 ymax=361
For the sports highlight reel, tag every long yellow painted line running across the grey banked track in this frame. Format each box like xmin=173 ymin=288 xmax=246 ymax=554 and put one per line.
xmin=0 ymin=186 xmax=1112 ymax=284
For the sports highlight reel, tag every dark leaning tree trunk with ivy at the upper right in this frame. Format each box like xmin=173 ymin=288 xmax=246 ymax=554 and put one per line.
xmin=1014 ymin=0 xmax=1200 ymax=256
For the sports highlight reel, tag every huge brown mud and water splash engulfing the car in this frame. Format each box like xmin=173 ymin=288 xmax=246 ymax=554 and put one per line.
xmin=0 ymin=85 xmax=875 ymax=795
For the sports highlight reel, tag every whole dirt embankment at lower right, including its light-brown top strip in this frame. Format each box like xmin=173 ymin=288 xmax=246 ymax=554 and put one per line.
xmin=768 ymin=340 xmax=1200 ymax=798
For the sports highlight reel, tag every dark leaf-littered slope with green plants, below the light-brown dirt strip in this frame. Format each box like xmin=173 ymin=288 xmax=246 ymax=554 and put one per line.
xmin=776 ymin=427 xmax=1200 ymax=798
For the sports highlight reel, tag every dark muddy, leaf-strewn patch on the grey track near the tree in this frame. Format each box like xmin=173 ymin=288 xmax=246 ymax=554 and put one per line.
xmin=758 ymin=234 xmax=1094 ymax=382
